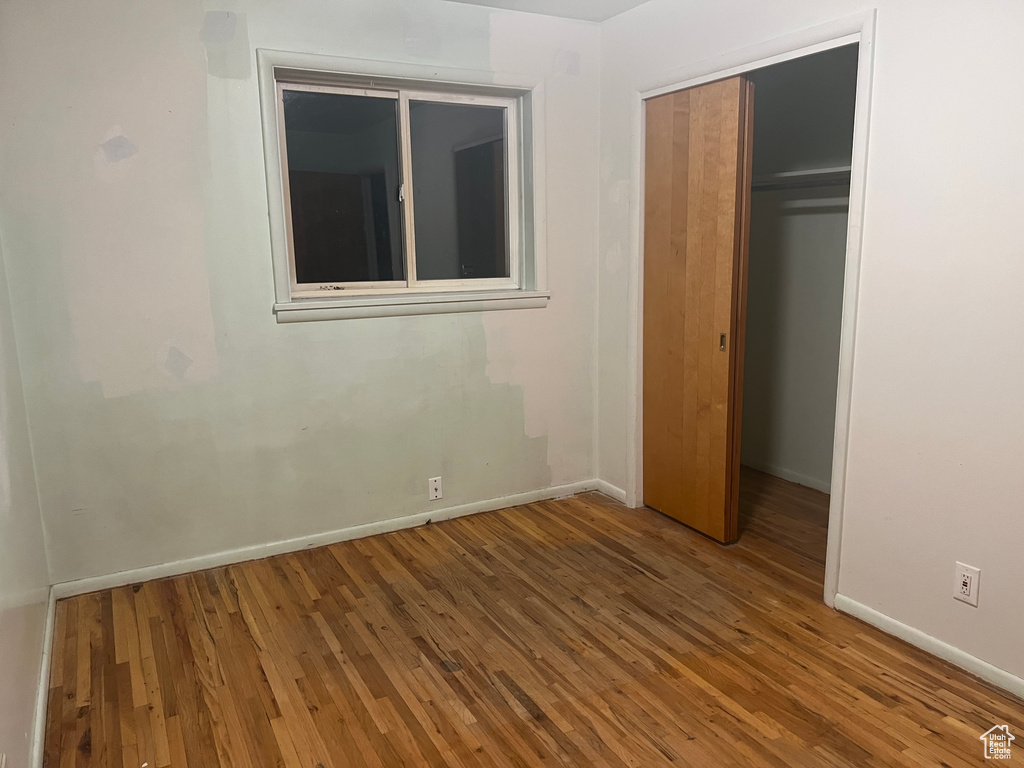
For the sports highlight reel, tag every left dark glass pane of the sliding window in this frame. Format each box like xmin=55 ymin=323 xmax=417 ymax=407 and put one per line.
xmin=284 ymin=90 xmax=406 ymax=284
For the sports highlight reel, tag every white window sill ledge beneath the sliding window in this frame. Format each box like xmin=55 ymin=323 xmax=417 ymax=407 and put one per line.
xmin=273 ymin=291 xmax=551 ymax=323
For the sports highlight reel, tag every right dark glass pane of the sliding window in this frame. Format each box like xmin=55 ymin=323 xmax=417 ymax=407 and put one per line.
xmin=410 ymin=101 xmax=509 ymax=280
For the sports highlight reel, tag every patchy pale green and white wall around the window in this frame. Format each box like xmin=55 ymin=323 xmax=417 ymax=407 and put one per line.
xmin=0 ymin=0 xmax=600 ymax=582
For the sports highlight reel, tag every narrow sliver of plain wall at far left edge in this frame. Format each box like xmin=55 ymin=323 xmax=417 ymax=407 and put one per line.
xmin=0 ymin=237 xmax=50 ymax=766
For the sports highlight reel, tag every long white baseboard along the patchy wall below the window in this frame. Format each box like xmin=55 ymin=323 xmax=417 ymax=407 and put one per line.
xmin=51 ymin=479 xmax=598 ymax=599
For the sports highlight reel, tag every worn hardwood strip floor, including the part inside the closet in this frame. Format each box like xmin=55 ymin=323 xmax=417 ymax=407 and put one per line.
xmin=44 ymin=472 xmax=1024 ymax=768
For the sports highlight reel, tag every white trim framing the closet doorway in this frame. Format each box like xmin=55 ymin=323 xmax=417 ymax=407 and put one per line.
xmin=626 ymin=9 xmax=877 ymax=607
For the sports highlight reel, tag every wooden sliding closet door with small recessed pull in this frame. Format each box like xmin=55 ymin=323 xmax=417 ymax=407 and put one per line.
xmin=643 ymin=78 xmax=754 ymax=542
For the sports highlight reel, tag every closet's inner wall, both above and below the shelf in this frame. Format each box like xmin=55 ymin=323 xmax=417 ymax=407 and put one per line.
xmin=740 ymin=46 xmax=857 ymax=492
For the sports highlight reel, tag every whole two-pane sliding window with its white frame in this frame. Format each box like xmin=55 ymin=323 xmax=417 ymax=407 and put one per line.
xmin=260 ymin=51 xmax=547 ymax=319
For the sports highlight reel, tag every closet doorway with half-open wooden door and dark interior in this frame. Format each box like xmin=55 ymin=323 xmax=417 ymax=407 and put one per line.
xmin=642 ymin=44 xmax=858 ymax=570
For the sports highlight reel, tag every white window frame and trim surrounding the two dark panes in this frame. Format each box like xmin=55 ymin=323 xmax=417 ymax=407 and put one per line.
xmin=257 ymin=49 xmax=550 ymax=323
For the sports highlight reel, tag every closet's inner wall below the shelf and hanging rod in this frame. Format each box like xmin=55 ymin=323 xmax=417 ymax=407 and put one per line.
xmin=740 ymin=191 xmax=849 ymax=493
